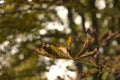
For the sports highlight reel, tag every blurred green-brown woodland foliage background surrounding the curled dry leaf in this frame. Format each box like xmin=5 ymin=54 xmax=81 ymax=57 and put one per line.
xmin=0 ymin=0 xmax=120 ymax=80
